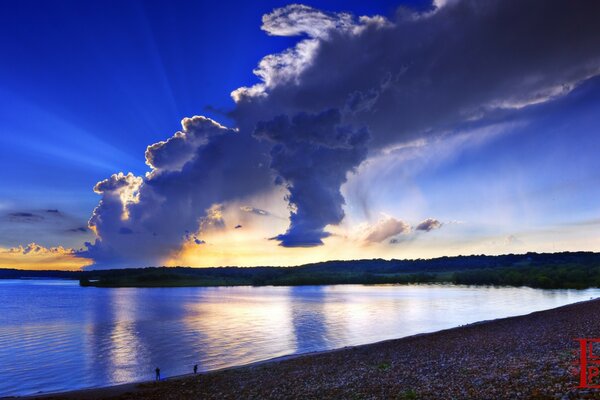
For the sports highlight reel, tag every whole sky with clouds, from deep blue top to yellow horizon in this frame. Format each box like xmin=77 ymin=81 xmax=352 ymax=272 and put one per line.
xmin=0 ymin=0 xmax=600 ymax=269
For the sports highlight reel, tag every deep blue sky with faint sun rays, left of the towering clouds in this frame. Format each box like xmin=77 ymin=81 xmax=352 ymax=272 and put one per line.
xmin=0 ymin=0 xmax=429 ymax=217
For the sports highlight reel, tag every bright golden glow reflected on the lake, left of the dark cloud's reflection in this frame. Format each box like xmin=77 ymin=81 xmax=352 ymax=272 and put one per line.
xmin=183 ymin=287 xmax=294 ymax=370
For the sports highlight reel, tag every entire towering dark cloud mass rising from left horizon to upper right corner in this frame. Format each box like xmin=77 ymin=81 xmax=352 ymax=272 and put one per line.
xmin=80 ymin=0 xmax=600 ymax=266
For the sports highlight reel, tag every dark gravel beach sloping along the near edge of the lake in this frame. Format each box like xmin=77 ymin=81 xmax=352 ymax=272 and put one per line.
xmin=31 ymin=300 xmax=600 ymax=400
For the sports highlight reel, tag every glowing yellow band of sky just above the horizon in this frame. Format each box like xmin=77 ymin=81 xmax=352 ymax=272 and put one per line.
xmin=0 ymin=205 xmax=600 ymax=270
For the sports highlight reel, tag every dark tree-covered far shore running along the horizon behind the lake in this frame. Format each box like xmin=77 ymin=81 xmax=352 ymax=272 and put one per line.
xmin=0 ymin=252 xmax=600 ymax=289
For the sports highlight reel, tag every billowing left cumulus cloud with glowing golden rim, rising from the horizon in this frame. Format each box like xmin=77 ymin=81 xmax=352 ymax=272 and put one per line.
xmin=79 ymin=117 xmax=271 ymax=268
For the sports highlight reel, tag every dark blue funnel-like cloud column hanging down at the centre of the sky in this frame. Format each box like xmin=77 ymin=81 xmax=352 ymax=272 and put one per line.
xmin=255 ymin=110 xmax=369 ymax=247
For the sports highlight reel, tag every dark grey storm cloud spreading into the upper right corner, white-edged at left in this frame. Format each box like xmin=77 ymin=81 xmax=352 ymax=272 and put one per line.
xmin=233 ymin=0 xmax=600 ymax=149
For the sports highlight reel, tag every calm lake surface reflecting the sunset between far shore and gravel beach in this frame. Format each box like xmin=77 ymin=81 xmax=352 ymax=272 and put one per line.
xmin=0 ymin=280 xmax=600 ymax=397
